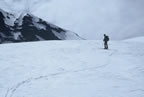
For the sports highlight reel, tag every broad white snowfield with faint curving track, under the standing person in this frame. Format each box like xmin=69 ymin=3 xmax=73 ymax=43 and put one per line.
xmin=0 ymin=37 xmax=144 ymax=97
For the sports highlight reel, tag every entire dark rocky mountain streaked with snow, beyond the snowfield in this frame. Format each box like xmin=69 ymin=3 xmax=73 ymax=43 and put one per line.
xmin=0 ymin=10 xmax=81 ymax=43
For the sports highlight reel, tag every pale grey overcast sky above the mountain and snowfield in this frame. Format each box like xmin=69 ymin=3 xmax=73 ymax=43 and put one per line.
xmin=0 ymin=0 xmax=144 ymax=39
